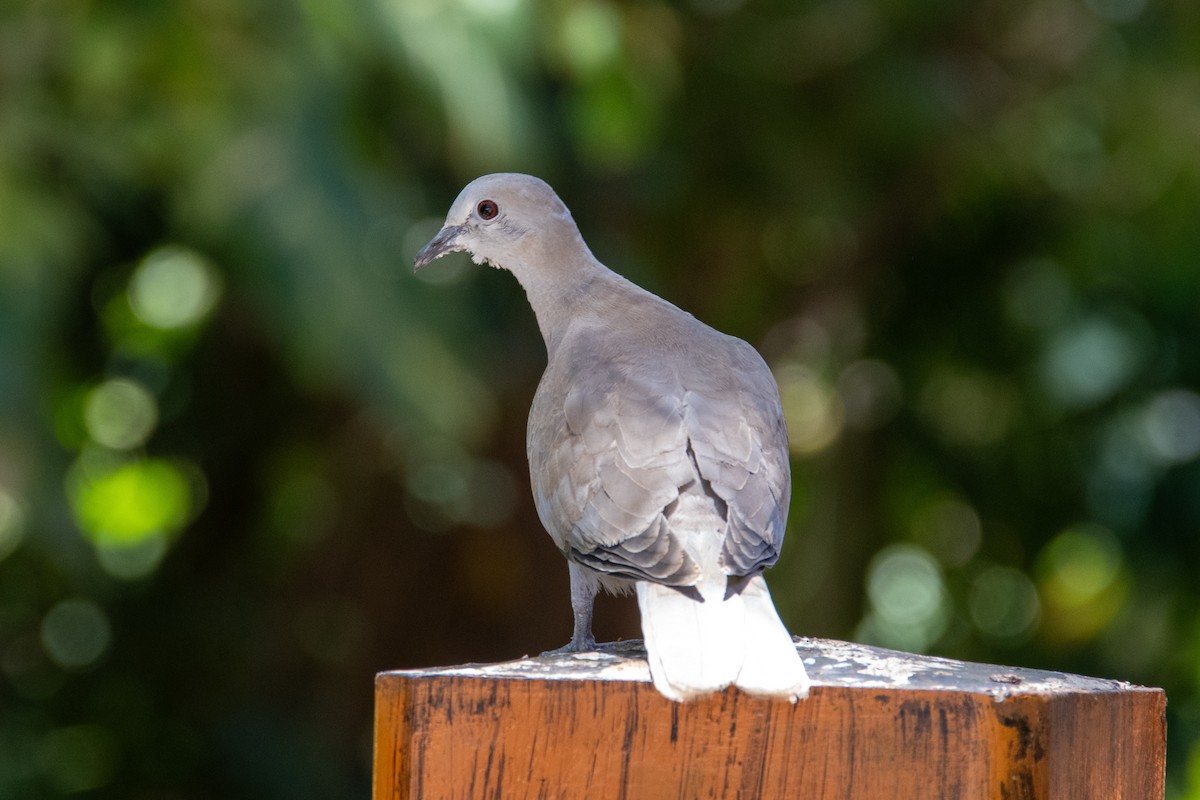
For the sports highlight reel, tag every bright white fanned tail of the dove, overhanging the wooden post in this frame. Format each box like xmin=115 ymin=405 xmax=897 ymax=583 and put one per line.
xmin=637 ymin=575 xmax=809 ymax=700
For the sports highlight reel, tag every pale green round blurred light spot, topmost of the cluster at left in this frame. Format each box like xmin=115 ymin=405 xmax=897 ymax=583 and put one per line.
xmin=128 ymin=246 xmax=221 ymax=330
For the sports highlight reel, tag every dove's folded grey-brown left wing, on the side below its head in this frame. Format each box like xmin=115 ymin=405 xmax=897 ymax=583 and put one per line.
xmin=529 ymin=340 xmax=696 ymax=585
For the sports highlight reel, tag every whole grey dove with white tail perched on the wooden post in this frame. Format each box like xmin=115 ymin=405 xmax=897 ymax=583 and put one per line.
xmin=415 ymin=174 xmax=809 ymax=700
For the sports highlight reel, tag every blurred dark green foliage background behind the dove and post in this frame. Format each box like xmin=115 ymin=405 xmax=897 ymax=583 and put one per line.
xmin=0 ymin=0 xmax=1200 ymax=800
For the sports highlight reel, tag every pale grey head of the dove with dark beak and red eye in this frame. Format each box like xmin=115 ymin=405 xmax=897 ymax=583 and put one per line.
xmin=413 ymin=173 xmax=583 ymax=270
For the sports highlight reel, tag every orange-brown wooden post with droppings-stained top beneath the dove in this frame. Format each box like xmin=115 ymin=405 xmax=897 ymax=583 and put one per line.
xmin=374 ymin=639 xmax=1166 ymax=800
